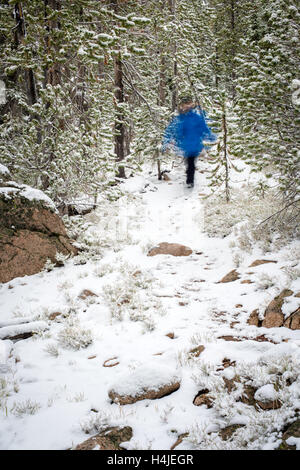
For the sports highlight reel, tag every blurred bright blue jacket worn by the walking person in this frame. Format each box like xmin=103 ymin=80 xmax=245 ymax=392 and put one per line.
xmin=162 ymin=107 xmax=216 ymax=158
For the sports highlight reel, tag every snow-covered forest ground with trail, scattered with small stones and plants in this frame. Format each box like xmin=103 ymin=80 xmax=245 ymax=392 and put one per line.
xmin=0 ymin=157 xmax=300 ymax=450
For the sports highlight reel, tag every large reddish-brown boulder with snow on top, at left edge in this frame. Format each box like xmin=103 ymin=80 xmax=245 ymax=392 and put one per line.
xmin=0 ymin=182 xmax=78 ymax=283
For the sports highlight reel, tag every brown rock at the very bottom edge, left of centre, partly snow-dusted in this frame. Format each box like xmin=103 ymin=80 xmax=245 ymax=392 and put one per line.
xmin=75 ymin=426 xmax=133 ymax=450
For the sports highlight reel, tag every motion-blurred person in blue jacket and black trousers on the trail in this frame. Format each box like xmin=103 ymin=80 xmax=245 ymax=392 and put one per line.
xmin=162 ymin=96 xmax=216 ymax=188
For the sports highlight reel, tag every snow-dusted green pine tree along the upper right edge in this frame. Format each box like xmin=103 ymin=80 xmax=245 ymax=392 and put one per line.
xmin=235 ymin=0 xmax=300 ymax=209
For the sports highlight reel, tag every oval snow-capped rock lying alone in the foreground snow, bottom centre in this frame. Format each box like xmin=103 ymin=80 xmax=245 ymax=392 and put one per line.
xmin=108 ymin=366 xmax=181 ymax=405
